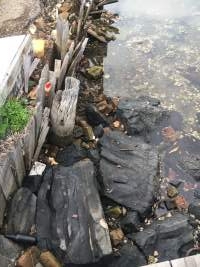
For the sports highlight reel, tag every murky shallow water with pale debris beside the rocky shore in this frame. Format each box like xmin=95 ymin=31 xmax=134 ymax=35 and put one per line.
xmin=104 ymin=0 xmax=200 ymax=205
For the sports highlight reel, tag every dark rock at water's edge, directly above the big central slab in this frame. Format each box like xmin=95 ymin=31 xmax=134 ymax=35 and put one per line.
xmin=117 ymin=96 xmax=168 ymax=135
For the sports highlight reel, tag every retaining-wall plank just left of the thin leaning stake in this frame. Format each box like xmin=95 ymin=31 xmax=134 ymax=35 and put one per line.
xmin=23 ymin=116 xmax=36 ymax=171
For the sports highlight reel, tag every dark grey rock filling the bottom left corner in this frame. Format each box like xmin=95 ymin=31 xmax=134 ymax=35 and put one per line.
xmin=0 ymin=235 xmax=23 ymax=267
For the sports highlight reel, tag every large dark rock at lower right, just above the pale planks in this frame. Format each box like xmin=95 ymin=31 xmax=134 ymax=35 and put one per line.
xmin=133 ymin=213 xmax=194 ymax=261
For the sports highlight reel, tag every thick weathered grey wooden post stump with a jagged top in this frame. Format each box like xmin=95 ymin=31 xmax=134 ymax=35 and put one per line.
xmin=51 ymin=77 xmax=80 ymax=137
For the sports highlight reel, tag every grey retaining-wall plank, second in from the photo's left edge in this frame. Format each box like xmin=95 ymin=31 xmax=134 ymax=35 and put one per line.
xmin=9 ymin=142 xmax=26 ymax=187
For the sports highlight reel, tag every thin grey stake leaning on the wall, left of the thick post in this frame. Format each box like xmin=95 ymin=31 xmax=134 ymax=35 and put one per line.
xmin=33 ymin=108 xmax=50 ymax=162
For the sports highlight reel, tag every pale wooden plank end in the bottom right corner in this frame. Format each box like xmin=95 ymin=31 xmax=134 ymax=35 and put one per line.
xmin=171 ymin=255 xmax=200 ymax=267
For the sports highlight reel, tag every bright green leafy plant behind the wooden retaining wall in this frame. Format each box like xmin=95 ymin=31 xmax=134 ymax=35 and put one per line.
xmin=0 ymin=99 xmax=30 ymax=138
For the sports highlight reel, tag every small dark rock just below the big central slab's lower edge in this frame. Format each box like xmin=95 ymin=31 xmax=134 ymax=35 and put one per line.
xmin=120 ymin=211 xmax=141 ymax=234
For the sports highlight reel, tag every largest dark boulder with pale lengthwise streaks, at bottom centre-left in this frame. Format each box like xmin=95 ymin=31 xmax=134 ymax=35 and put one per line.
xmin=37 ymin=160 xmax=112 ymax=264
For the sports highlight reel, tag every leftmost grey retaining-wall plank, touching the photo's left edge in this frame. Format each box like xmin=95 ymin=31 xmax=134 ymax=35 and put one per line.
xmin=0 ymin=154 xmax=17 ymax=200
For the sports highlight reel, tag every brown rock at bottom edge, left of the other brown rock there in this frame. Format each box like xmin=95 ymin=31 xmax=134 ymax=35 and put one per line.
xmin=16 ymin=247 xmax=40 ymax=267
